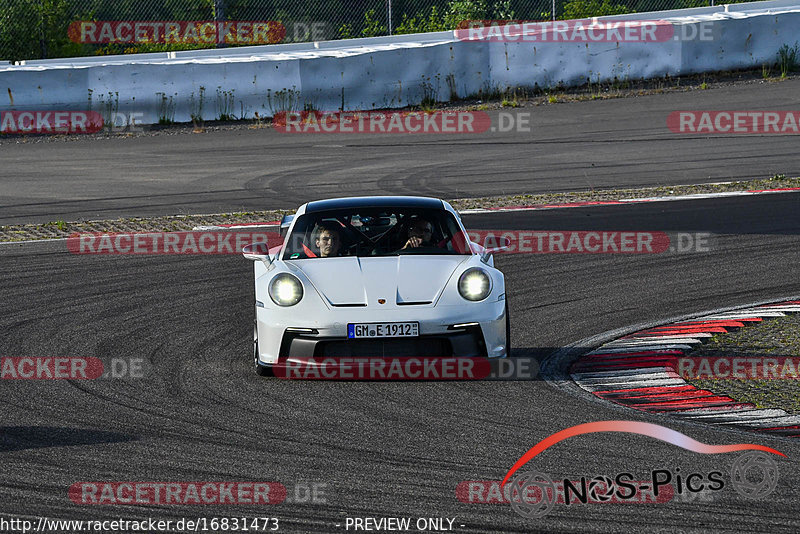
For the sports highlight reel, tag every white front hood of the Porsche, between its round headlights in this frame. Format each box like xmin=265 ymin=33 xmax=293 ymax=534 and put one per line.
xmin=291 ymin=255 xmax=470 ymax=306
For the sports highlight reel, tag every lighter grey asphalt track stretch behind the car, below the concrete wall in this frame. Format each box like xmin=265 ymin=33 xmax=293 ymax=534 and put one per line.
xmin=0 ymin=79 xmax=800 ymax=224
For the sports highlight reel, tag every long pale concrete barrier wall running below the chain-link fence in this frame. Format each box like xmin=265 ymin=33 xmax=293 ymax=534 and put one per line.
xmin=0 ymin=0 xmax=800 ymax=124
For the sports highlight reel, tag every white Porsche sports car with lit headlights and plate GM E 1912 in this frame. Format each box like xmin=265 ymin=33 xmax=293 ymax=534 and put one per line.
xmin=244 ymin=197 xmax=510 ymax=376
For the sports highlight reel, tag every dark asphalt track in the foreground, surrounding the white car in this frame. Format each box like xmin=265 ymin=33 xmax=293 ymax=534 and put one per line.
xmin=0 ymin=194 xmax=800 ymax=533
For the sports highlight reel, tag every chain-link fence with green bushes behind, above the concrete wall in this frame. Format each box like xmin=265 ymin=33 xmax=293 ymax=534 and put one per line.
xmin=0 ymin=0 xmax=764 ymax=61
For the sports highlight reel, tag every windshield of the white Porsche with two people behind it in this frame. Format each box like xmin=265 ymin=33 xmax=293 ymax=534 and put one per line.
xmin=283 ymin=208 xmax=471 ymax=260
